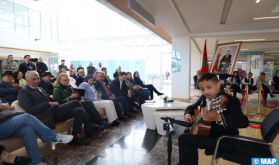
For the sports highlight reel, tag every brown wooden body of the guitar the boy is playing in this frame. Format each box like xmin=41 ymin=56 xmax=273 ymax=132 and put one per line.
xmin=190 ymin=108 xmax=211 ymax=137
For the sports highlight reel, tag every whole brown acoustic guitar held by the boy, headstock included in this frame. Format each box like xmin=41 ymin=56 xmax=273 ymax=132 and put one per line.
xmin=190 ymin=95 xmax=228 ymax=137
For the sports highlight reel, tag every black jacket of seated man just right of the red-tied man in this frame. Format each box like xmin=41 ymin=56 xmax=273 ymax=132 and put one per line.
xmin=109 ymin=77 xmax=130 ymax=97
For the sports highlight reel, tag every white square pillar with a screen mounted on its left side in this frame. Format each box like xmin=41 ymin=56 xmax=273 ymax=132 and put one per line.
xmin=172 ymin=36 xmax=191 ymax=99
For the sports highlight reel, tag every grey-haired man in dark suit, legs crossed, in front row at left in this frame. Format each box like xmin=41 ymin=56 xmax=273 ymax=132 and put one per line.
xmin=18 ymin=71 xmax=99 ymax=145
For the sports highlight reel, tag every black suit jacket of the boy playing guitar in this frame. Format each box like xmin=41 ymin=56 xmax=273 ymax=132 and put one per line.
xmin=184 ymin=91 xmax=249 ymax=137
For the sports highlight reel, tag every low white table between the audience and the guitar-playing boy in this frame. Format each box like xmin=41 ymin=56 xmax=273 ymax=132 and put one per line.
xmin=141 ymin=100 xmax=190 ymax=133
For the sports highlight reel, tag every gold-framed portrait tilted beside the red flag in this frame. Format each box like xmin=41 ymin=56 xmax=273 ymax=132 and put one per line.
xmin=209 ymin=41 xmax=242 ymax=74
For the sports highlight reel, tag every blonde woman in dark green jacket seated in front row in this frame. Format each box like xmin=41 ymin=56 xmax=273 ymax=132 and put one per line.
xmin=53 ymin=73 xmax=109 ymax=127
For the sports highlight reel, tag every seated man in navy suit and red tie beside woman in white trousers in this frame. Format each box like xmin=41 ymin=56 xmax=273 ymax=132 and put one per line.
xmin=93 ymin=72 xmax=135 ymax=120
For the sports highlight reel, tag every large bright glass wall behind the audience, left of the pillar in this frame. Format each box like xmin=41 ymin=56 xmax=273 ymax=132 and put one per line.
xmin=58 ymin=0 xmax=171 ymax=83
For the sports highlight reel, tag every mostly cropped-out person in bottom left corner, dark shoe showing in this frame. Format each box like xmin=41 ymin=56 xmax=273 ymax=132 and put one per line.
xmin=0 ymin=145 xmax=32 ymax=165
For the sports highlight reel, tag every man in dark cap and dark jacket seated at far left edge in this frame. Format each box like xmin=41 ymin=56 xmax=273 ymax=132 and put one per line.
xmin=0 ymin=71 xmax=22 ymax=104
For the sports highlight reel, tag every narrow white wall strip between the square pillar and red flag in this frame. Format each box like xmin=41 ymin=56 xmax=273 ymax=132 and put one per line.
xmin=191 ymin=40 xmax=202 ymax=84
